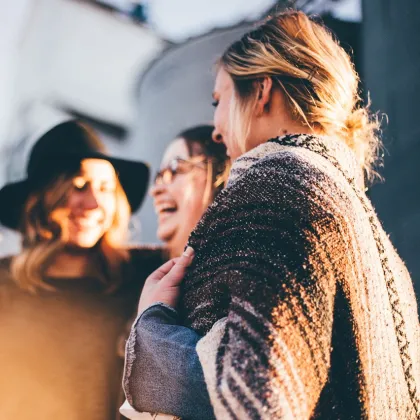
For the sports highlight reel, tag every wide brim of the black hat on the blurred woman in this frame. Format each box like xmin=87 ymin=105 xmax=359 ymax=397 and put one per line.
xmin=0 ymin=152 xmax=150 ymax=230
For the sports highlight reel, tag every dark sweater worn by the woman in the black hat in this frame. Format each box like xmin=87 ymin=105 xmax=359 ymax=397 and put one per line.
xmin=0 ymin=249 xmax=162 ymax=420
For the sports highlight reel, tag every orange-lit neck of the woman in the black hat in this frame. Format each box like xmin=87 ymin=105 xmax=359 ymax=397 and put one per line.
xmin=46 ymin=249 xmax=95 ymax=277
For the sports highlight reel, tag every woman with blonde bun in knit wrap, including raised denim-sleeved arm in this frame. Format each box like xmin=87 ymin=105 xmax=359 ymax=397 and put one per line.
xmin=125 ymin=11 xmax=420 ymax=420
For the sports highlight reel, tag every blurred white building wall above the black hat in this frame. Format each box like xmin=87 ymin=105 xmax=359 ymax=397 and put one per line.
xmin=7 ymin=0 xmax=163 ymax=138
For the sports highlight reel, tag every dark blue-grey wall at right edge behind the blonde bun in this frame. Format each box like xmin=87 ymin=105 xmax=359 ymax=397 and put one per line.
xmin=362 ymin=0 xmax=420 ymax=297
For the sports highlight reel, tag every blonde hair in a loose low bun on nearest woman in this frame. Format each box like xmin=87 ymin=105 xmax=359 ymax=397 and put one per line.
xmin=219 ymin=10 xmax=381 ymax=179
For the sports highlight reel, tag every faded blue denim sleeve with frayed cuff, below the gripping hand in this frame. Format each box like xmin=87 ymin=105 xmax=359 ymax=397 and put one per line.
xmin=123 ymin=303 xmax=215 ymax=420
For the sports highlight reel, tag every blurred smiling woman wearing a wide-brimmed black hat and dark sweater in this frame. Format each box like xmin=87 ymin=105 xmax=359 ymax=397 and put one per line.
xmin=0 ymin=121 xmax=162 ymax=420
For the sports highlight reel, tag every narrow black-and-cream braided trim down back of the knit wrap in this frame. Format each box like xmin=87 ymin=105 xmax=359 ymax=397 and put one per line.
xmin=269 ymin=135 xmax=420 ymax=418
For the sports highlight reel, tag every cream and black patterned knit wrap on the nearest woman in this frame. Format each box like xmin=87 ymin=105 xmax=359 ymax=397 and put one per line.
xmin=181 ymin=135 xmax=420 ymax=420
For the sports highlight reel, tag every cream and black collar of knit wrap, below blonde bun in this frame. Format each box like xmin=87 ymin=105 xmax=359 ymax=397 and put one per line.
xmin=228 ymin=134 xmax=364 ymax=189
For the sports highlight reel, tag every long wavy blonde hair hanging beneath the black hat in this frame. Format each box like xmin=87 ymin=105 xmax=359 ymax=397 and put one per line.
xmin=11 ymin=169 xmax=130 ymax=293
